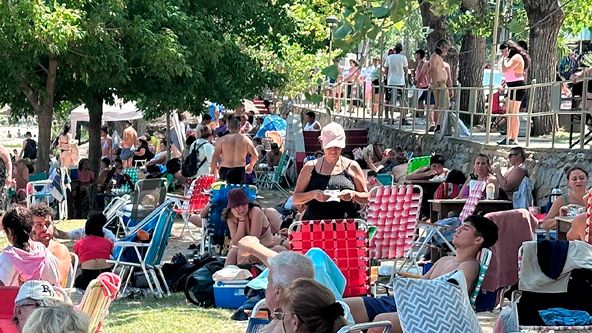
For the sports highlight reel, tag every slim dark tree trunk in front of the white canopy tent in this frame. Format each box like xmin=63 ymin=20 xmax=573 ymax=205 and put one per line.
xmin=84 ymin=96 xmax=103 ymax=175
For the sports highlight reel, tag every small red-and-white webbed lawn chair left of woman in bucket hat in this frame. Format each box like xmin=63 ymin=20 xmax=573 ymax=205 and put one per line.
xmin=167 ymin=175 xmax=216 ymax=240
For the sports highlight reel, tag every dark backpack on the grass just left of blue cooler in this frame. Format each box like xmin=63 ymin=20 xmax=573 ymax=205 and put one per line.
xmin=184 ymin=260 xmax=224 ymax=308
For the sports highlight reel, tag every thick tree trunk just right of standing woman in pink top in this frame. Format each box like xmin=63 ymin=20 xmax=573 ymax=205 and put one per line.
xmin=524 ymin=0 xmax=565 ymax=136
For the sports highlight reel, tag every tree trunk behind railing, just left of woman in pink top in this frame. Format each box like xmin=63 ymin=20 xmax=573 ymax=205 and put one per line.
xmin=458 ymin=0 xmax=485 ymax=124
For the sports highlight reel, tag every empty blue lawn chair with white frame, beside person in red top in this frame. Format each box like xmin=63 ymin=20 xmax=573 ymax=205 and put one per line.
xmin=108 ymin=199 xmax=175 ymax=297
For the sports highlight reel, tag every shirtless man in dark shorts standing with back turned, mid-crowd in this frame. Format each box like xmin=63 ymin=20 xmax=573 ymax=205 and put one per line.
xmin=211 ymin=117 xmax=258 ymax=180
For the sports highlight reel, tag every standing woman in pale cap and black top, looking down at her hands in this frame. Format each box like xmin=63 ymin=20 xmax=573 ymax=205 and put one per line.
xmin=294 ymin=123 xmax=368 ymax=220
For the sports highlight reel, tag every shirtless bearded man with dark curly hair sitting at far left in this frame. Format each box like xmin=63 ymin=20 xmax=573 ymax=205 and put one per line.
xmin=31 ymin=202 xmax=72 ymax=287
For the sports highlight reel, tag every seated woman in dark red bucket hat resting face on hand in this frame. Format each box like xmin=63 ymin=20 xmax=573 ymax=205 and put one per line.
xmin=222 ymin=188 xmax=287 ymax=265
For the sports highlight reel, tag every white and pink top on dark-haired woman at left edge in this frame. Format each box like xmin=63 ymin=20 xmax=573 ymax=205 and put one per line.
xmin=0 ymin=242 xmax=60 ymax=287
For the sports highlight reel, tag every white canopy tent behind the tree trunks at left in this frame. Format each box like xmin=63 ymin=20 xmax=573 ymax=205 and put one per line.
xmin=70 ymin=99 xmax=144 ymax=133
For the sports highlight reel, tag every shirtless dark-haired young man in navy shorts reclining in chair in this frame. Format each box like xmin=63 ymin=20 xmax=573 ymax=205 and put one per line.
xmin=345 ymin=215 xmax=498 ymax=332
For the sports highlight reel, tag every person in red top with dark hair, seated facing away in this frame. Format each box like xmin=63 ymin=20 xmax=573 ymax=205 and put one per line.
xmin=74 ymin=213 xmax=113 ymax=289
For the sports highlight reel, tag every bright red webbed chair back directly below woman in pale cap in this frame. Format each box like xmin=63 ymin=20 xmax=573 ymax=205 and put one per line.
xmin=288 ymin=219 xmax=370 ymax=297
